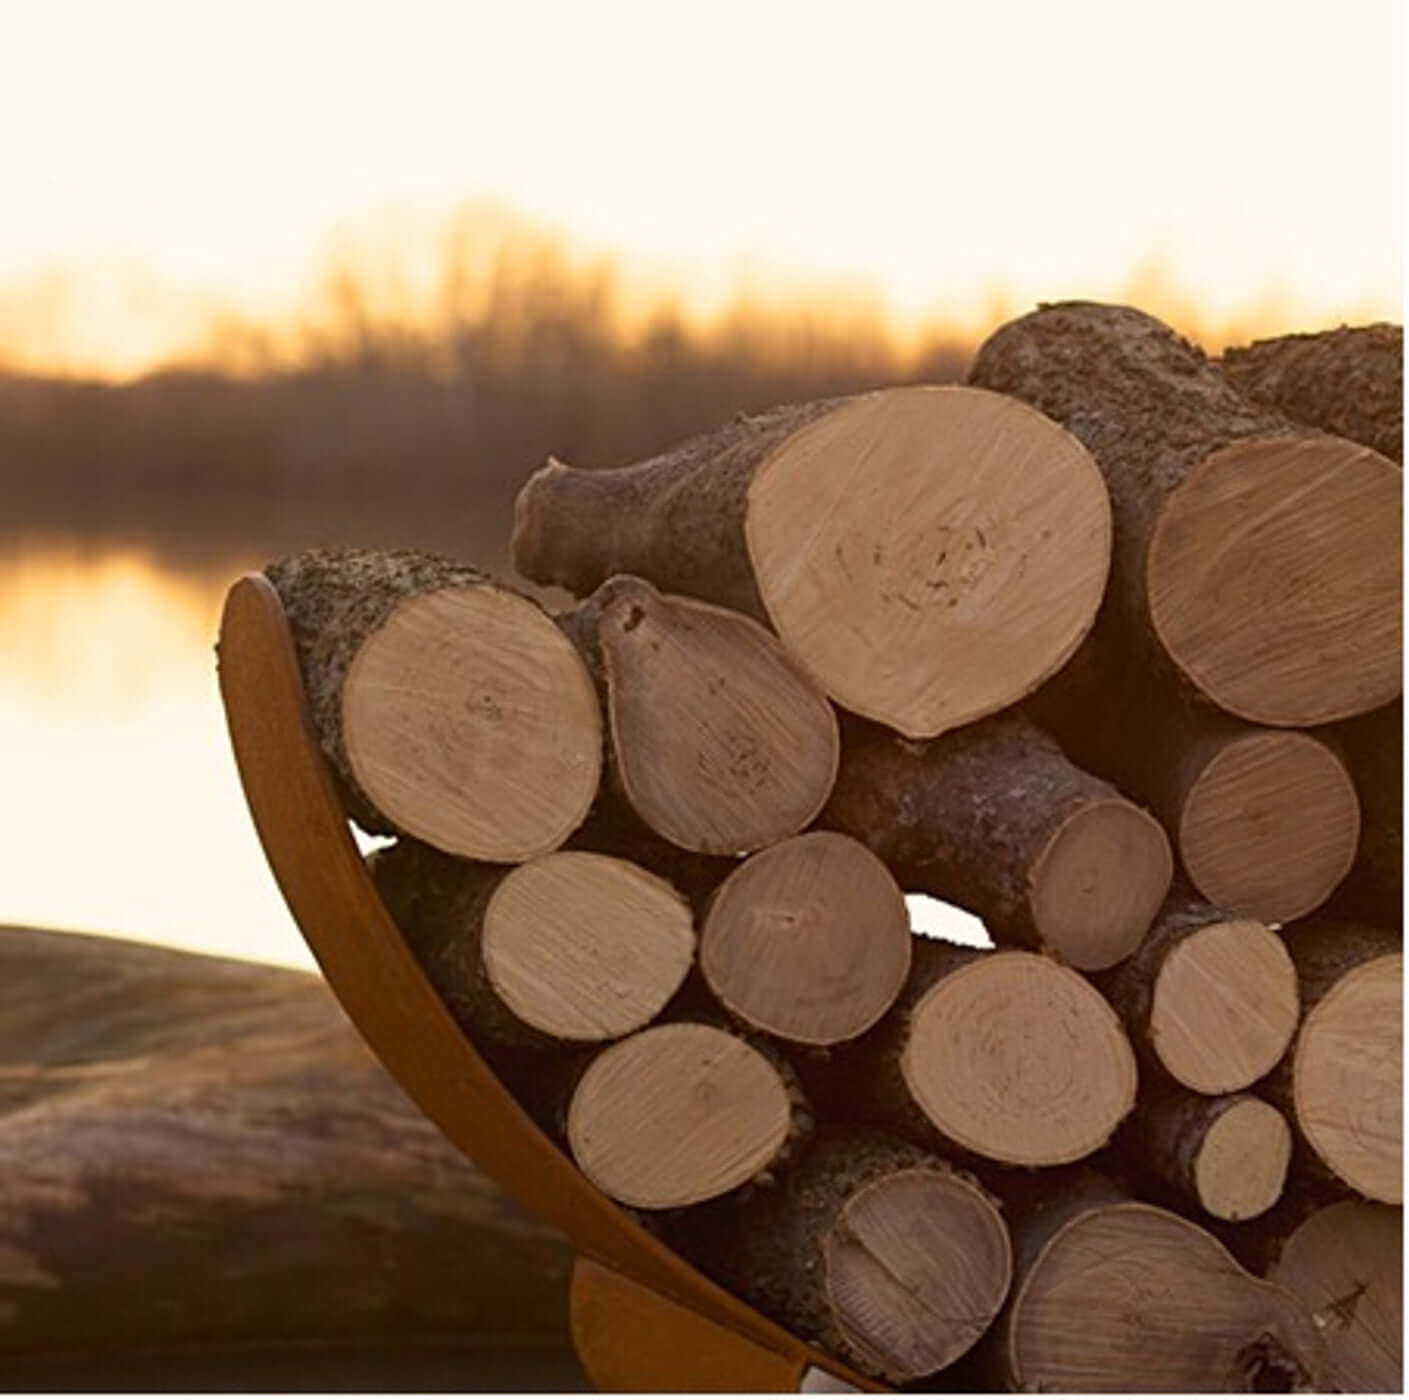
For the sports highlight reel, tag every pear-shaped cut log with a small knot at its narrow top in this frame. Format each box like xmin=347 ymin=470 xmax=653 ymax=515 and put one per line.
xmin=559 ymin=575 xmax=840 ymax=855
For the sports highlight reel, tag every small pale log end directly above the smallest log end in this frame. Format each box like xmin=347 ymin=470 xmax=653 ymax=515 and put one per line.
xmin=1148 ymin=918 xmax=1301 ymax=1094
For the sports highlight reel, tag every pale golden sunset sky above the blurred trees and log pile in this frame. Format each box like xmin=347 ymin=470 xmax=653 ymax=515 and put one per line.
xmin=0 ymin=0 xmax=1402 ymax=373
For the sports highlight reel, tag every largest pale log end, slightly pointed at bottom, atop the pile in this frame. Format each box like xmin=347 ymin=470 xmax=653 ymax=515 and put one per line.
xmin=745 ymin=387 xmax=1112 ymax=738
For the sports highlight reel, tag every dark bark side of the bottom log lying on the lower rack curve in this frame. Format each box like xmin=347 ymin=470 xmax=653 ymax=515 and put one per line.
xmin=666 ymin=1127 xmax=996 ymax=1380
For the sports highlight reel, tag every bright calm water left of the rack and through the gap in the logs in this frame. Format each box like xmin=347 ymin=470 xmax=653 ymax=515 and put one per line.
xmin=0 ymin=548 xmax=986 ymax=966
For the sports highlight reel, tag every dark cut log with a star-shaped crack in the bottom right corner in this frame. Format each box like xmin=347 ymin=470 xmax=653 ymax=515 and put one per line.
xmin=1268 ymin=1200 xmax=1403 ymax=1394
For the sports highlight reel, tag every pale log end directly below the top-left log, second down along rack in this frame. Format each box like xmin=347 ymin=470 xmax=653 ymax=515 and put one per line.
xmin=480 ymin=851 xmax=695 ymax=1041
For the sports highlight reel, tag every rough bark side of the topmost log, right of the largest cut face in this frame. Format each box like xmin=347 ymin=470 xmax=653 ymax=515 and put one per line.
xmin=969 ymin=301 xmax=1306 ymax=685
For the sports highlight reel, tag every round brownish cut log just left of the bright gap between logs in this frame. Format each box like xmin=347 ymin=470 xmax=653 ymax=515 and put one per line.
xmin=700 ymin=831 xmax=910 ymax=1045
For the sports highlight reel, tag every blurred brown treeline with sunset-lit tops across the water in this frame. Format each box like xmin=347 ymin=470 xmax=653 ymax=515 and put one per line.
xmin=0 ymin=233 xmax=968 ymax=572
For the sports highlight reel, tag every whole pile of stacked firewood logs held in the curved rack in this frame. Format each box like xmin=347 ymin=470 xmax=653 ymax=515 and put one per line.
xmin=268 ymin=303 xmax=1402 ymax=1392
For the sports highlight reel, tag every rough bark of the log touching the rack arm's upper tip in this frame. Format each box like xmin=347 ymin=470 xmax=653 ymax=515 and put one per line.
xmin=263 ymin=549 xmax=493 ymax=834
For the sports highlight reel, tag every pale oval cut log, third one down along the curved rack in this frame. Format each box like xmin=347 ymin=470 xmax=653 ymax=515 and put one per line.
xmin=566 ymin=1021 xmax=810 ymax=1210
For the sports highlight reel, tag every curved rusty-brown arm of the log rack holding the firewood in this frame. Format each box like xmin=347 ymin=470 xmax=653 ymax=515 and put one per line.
xmin=218 ymin=575 xmax=871 ymax=1389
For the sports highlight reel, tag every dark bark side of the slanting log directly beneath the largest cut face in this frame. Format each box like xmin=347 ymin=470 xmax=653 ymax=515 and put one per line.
xmin=820 ymin=711 xmax=1161 ymax=948
